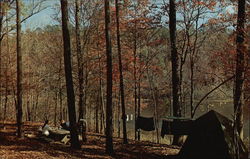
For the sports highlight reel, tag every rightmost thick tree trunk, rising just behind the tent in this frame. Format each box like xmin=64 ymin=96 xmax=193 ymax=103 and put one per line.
xmin=234 ymin=0 xmax=246 ymax=138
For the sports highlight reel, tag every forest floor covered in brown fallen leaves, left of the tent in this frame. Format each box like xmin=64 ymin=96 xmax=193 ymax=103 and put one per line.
xmin=0 ymin=122 xmax=179 ymax=159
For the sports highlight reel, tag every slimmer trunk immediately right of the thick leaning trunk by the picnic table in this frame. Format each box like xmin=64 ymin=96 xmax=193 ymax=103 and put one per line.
xmin=75 ymin=0 xmax=87 ymax=142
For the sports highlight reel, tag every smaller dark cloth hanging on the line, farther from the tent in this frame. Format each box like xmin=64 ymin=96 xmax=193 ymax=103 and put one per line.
xmin=136 ymin=116 xmax=155 ymax=131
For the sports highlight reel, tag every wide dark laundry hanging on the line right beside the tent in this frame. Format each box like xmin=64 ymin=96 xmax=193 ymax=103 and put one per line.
xmin=161 ymin=120 xmax=193 ymax=138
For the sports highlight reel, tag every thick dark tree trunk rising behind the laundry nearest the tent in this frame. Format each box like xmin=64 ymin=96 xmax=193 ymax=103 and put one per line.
xmin=169 ymin=0 xmax=181 ymax=145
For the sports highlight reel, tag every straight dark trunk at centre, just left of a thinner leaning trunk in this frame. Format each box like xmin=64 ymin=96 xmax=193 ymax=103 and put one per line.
xmin=104 ymin=0 xmax=114 ymax=155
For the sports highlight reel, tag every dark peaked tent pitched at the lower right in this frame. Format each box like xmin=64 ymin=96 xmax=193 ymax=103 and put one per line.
xmin=178 ymin=110 xmax=248 ymax=159
